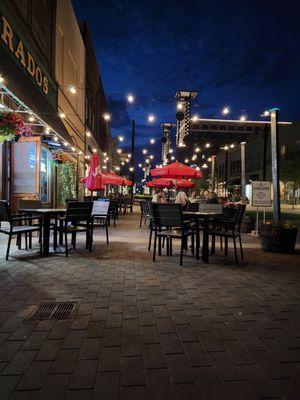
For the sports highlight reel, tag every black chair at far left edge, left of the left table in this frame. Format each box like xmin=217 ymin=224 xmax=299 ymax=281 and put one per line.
xmin=0 ymin=200 xmax=42 ymax=260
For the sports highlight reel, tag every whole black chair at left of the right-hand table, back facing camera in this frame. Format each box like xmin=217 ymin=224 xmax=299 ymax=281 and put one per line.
xmin=152 ymin=203 xmax=199 ymax=265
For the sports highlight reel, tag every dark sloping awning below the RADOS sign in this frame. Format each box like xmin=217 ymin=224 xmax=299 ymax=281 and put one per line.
xmin=0 ymin=48 xmax=74 ymax=145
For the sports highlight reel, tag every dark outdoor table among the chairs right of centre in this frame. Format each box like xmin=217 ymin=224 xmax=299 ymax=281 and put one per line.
xmin=182 ymin=211 xmax=222 ymax=263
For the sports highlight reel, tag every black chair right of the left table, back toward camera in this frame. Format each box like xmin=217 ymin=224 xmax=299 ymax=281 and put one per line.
xmin=53 ymin=201 xmax=93 ymax=257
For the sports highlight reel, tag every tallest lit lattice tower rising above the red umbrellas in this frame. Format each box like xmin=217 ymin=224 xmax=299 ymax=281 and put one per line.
xmin=175 ymin=90 xmax=198 ymax=147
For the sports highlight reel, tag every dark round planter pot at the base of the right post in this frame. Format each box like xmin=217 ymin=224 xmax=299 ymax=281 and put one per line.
xmin=259 ymin=225 xmax=297 ymax=253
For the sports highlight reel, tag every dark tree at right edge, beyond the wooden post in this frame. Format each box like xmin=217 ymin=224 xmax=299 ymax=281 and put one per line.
xmin=279 ymin=152 xmax=300 ymax=207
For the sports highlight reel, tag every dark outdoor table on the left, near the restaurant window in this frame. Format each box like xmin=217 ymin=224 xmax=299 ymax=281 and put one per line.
xmin=20 ymin=208 xmax=66 ymax=257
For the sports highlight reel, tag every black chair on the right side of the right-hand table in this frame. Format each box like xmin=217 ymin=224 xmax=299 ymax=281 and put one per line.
xmin=210 ymin=204 xmax=246 ymax=264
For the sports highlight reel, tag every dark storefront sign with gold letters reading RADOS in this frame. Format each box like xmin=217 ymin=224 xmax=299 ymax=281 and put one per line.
xmin=0 ymin=5 xmax=57 ymax=106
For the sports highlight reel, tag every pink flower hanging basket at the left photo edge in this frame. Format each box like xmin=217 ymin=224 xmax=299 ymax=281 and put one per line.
xmin=0 ymin=112 xmax=32 ymax=143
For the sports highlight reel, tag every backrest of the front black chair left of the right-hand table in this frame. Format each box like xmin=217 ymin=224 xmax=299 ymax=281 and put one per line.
xmin=152 ymin=203 xmax=182 ymax=227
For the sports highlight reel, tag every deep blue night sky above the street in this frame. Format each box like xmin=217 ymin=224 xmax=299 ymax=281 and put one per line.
xmin=73 ymin=0 xmax=300 ymax=161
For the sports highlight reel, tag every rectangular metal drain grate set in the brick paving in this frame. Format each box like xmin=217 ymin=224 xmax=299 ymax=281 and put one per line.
xmin=30 ymin=303 xmax=75 ymax=321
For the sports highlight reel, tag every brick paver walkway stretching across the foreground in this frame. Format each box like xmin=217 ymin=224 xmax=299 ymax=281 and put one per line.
xmin=0 ymin=211 xmax=300 ymax=400
